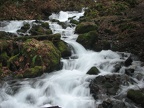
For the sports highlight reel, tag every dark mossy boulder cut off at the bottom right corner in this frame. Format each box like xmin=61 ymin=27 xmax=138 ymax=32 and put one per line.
xmin=127 ymin=89 xmax=144 ymax=107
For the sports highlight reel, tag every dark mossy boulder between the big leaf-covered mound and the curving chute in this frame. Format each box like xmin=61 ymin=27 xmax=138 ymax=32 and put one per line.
xmin=54 ymin=40 xmax=71 ymax=57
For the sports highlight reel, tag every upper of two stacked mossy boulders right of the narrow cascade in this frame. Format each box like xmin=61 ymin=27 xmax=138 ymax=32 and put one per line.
xmin=75 ymin=22 xmax=98 ymax=34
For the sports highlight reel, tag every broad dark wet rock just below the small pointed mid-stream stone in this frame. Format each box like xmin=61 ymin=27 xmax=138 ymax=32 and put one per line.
xmin=89 ymin=75 xmax=136 ymax=100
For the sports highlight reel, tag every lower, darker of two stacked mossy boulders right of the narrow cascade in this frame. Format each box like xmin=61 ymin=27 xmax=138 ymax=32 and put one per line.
xmin=77 ymin=31 xmax=98 ymax=49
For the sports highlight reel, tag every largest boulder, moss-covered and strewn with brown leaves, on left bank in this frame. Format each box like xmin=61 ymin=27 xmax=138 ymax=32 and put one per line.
xmin=0 ymin=38 xmax=61 ymax=78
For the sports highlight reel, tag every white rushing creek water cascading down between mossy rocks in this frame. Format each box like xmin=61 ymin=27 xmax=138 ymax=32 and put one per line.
xmin=0 ymin=11 xmax=144 ymax=108
